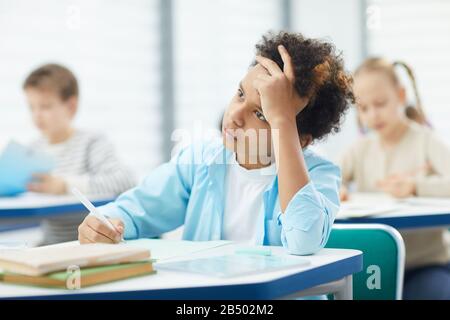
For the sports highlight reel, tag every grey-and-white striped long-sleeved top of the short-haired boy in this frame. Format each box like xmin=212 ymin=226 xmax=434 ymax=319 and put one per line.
xmin=31 ymin=130 xmax=135 ymax=244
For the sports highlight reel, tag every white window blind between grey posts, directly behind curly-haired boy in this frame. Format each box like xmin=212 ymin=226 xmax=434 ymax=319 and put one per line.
xmin=173 ymin=0 xmax=283 ymax=144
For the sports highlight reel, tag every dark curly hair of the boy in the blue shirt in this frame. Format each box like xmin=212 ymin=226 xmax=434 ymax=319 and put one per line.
xmin=252 ymin=31 xmax=354 ymax=140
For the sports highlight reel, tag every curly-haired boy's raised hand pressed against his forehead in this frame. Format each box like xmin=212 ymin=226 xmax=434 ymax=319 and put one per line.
xmin=253 ymin=45 xmax=308 ymax=124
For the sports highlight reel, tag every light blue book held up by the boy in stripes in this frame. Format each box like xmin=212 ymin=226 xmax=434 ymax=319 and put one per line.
xmin=0 ymin=141 xmax=54 ymax=196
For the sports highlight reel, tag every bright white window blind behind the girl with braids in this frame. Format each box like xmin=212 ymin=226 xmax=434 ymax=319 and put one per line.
xmin=367 ymin=0 xmax=450 ymax=143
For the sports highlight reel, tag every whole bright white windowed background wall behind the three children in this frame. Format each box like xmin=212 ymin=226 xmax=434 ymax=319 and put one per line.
xmin=0 ymin=0 xmax=450 ymax=178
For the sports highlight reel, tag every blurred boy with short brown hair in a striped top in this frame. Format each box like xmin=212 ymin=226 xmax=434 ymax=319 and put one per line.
xmin=23 ymin=64 xmax=134 ymax=244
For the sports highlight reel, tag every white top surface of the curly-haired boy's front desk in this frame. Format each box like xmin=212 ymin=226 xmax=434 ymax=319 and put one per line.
xmin=0 ymin=244 xmax=362 ymax=298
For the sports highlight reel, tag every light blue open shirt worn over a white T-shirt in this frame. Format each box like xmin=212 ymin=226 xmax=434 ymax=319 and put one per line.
xmin=100 ymin=142 xmax=341 ymax=255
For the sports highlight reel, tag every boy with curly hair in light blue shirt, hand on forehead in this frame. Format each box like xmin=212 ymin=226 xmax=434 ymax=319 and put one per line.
xmin=79 ymin=32 xmax=353 ymax=255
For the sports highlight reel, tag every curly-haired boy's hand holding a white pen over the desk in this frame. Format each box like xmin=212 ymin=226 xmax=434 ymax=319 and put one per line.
xmin=78 ymin=215 xmax=124 ymax=244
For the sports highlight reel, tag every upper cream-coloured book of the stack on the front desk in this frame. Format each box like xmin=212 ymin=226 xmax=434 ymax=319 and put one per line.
xmin=0 ymin=242 xmax=150 ymax=276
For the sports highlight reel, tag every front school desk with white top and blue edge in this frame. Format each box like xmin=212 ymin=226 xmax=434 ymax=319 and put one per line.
xmin=0 ymin=243 xmax=362 ymax=300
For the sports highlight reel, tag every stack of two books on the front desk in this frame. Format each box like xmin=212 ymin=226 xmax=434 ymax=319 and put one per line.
xmin=0 ymin=243 xmax=155 ymax=289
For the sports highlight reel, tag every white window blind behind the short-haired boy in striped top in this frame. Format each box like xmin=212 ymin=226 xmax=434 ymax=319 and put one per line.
xmin=0 ymin=0 xmax=162 ymax=176
